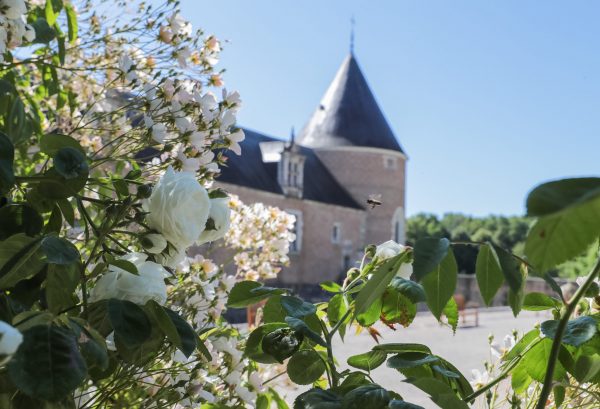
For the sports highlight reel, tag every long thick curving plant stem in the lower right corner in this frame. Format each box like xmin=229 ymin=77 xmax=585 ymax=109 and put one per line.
xmin=535 ymin=258 xmax=600 ymax=409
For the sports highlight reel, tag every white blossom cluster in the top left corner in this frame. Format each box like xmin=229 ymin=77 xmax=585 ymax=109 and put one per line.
xmin=0 ymin=0 xmax=35 ymax=63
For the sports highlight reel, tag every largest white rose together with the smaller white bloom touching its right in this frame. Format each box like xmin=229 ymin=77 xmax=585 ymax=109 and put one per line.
xmin=145 ymin=167 xmax=230 ymax=267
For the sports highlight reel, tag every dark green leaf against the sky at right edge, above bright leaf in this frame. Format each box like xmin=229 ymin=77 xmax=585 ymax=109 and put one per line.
xmin=527 ymin=178 xmax=600 ymax=217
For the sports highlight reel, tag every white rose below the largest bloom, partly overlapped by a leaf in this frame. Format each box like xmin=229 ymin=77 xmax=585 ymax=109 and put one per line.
xmin=90 ymin=253 xmax=168 ymax=305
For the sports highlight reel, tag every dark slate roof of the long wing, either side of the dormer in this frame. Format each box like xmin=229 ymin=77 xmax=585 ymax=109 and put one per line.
xmin=217 ymin=129 xmax=363 ymax=209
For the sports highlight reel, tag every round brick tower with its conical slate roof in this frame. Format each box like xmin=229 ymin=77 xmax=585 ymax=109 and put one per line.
xmin=298 ymin=53 xmax=407 ymax=244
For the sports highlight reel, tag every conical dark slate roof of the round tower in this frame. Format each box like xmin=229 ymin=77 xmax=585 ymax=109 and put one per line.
xmin=298 ymin=53 xmax=403 ymax=152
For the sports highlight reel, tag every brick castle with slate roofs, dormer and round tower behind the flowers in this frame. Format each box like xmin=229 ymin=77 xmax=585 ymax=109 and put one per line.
xmin=217 ymin=52 xmax=407 ymax=292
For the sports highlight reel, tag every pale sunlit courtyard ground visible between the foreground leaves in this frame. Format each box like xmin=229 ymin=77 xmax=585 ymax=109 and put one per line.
xmin=279 ymin=308 xmax=551 ymax=409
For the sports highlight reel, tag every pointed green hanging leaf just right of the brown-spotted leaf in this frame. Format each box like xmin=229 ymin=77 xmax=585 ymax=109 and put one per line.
xmin=422 ymin=250 xmax=458 ymax=320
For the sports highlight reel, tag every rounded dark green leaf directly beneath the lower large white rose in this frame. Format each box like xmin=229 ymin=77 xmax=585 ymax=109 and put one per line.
xmin=107 ymin=298 xmax=152 ymax=347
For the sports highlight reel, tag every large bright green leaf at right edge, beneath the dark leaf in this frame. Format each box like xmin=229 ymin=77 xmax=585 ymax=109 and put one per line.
xmin=525 ymin=195 xmax=600 ymax=273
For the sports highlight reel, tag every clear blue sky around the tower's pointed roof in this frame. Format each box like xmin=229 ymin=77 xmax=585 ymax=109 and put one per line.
xmin=182 ymin=0 xmax=600 ymax=215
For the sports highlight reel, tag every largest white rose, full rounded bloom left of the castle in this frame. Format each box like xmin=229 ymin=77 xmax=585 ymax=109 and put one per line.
xmin=146 ymin=167 xmax=210 ymax=249
